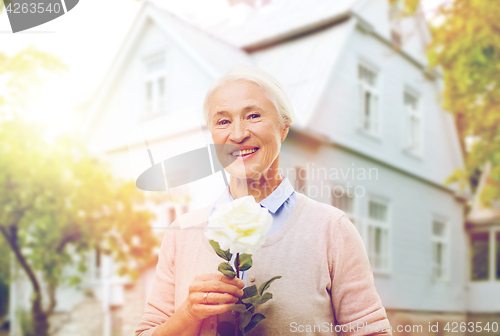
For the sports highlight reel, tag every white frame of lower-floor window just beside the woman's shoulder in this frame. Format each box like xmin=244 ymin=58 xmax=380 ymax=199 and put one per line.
xmin=365 ymin=197 xmax=391 ymax=274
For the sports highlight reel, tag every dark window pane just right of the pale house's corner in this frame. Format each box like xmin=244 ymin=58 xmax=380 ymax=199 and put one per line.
xmin=470 ymin=232 xmax=490 ymax=281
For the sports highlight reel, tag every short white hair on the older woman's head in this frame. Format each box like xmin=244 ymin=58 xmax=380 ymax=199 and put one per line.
xmin=203 ymin=65 xmax=295 ymax=128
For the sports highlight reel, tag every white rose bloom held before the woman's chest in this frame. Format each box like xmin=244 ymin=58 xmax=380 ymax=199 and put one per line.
xmin=205 ymin=196 xmax=273 ymax=254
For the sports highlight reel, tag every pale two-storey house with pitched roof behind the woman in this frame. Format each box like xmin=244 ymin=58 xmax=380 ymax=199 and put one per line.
xmin=29 ymin=0 xmax=472 ymax=335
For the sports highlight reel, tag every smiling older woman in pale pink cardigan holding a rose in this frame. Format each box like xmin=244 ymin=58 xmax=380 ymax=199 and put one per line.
xmin=136 ymin=66 xmax=391 ymax=336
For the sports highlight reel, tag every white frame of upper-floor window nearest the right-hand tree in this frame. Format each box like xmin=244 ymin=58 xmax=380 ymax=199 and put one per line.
xmin=403 ymin=88 xmax=424 ymax=156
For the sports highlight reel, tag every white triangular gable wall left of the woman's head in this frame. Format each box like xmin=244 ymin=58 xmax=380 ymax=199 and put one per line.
xmin=89 ymin=15 xmax=216 ymax=152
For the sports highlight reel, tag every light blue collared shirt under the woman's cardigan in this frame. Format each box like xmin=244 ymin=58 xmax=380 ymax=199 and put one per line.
xmin=210 ymin=175 xmax=297 ymax=284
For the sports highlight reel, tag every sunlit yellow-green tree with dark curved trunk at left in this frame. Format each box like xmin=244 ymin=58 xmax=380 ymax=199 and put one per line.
xmin=0 ymin=48 xmax=158 ymax=336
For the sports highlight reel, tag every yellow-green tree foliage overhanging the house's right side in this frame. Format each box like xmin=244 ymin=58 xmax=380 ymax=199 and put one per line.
xmin=390 ymin=0 xmax=500 ymax=203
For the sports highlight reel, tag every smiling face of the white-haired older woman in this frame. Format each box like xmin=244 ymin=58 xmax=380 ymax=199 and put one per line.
xmin=208 ymin=80 xmax=288 ymax=179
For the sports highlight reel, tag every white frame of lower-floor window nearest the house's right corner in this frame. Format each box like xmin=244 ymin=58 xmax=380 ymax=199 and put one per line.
xmin=430 ymin=216 xmax=450 ymax=282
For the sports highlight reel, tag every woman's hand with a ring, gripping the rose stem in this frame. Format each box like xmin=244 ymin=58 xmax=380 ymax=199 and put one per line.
xmin=184 ymin=274 xmax=245 ymax=321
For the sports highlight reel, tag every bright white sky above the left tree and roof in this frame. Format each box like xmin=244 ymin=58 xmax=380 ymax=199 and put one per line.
xmin=0 ymin=0 xmax=449 ymax=136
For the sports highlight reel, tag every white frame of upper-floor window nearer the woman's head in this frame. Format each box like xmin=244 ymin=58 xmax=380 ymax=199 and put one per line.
xmin=357 ymin=61 xmax=381 ymax=136
